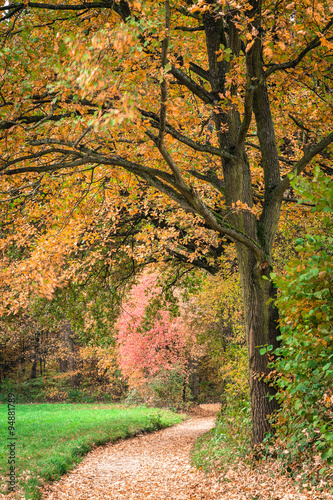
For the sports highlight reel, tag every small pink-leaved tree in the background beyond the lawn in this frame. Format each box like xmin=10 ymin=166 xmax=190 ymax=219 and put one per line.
xmin=115 ymin=270 xmax=200 ymax=400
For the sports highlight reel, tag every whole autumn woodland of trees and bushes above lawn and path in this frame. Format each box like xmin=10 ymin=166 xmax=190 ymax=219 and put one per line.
xmin=0 ymin=0 xmax=333 ymax=492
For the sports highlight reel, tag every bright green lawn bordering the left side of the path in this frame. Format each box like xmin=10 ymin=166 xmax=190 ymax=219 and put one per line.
xmin=0 ymin=404 xmax=184 ymax=500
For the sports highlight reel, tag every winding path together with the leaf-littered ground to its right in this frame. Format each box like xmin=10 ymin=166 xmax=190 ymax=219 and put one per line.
xmin=43 ymin=405 xmax=333 ymax=500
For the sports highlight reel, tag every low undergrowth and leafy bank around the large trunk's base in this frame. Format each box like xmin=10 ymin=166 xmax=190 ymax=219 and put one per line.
xmin=191 ymin=396 xmax=333 ymax=493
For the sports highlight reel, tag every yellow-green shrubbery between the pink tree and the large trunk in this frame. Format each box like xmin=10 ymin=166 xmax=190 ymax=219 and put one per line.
xmin=195 ymin=266 xmax=248 ymax=402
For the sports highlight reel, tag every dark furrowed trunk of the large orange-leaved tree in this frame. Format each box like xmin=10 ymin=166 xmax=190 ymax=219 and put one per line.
xmin=203 ymin=0 xmax=281 ymax=444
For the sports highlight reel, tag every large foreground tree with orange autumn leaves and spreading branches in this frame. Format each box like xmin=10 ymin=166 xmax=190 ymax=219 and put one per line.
xmin=0 ymin=0 xmax=333 ymax=443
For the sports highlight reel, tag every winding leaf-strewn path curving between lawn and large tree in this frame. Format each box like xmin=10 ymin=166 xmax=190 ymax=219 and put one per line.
xmin=43 ymin=406 xmax=217 ymax=500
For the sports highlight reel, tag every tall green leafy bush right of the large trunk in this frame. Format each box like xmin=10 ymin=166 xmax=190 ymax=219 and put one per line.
xmin=271 ymin=169 xmax=333 ymax=473
